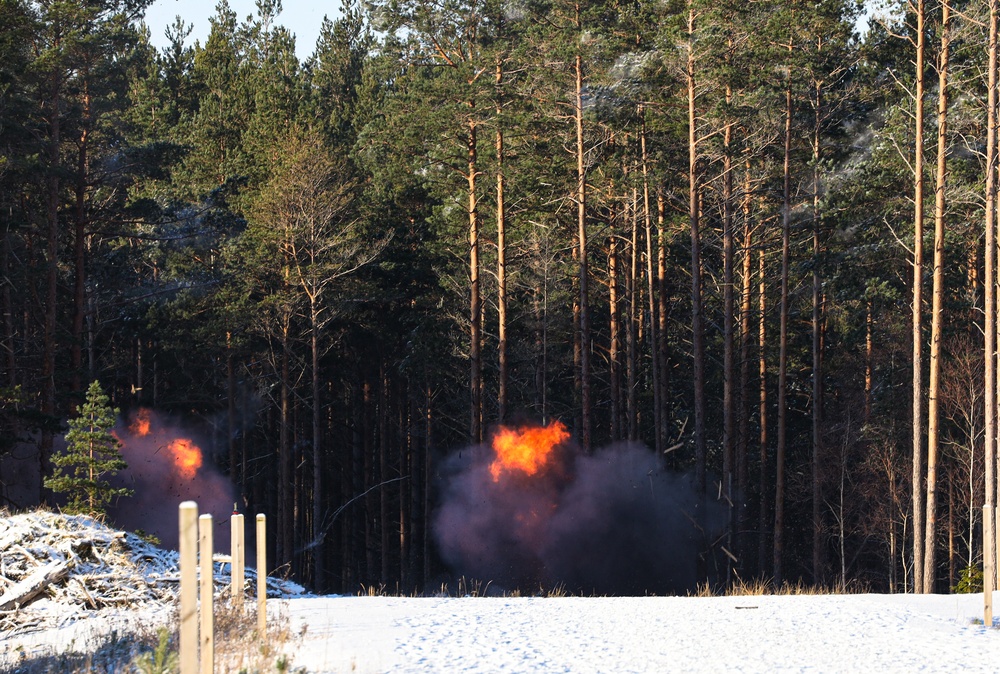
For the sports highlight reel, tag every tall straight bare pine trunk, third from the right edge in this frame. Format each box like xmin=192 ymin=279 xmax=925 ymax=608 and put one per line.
xmin=912 ymin=0 xmax=924 ymax=594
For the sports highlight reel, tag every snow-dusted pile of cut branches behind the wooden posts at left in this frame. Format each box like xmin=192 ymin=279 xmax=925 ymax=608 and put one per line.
xmin=0 ymin=510 xmax=302 ymax=636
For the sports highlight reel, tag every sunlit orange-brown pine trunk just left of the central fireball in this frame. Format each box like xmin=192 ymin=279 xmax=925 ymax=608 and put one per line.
xmin=467 ymin=118 xmax=483 ymax=444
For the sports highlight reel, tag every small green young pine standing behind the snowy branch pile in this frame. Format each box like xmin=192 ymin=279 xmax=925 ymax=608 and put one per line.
xmin=45 ymin=381 xmax=132 ymax=515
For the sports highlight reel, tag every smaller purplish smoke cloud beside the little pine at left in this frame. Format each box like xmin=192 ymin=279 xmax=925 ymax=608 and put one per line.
xmin=108 ymin=410 xmax=236 ymax=551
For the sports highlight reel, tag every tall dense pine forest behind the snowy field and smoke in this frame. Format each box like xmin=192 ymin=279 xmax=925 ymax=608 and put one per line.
xmin=0 ymin=0 xmax=996 ymax=591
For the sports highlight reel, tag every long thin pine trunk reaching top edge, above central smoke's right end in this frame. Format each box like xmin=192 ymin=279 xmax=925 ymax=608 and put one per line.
xmin=686 ymin=0 xmax=708 ymax=492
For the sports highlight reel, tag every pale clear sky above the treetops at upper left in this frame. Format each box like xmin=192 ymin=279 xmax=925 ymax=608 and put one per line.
xmin=146 ymin=0 xmax=340 ymax=60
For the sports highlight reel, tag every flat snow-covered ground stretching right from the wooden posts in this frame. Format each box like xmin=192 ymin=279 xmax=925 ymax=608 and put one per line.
xmin=271 ymin=593 xmax=1000 ymax=673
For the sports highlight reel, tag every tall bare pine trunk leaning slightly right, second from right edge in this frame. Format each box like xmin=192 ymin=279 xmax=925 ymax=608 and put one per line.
xmin=918 ymin=0 xmax=951 ymax=592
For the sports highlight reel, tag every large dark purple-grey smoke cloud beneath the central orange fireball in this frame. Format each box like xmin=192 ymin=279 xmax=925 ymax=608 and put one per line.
xmin=434 ymin=434 xmax=725 ymax=595
